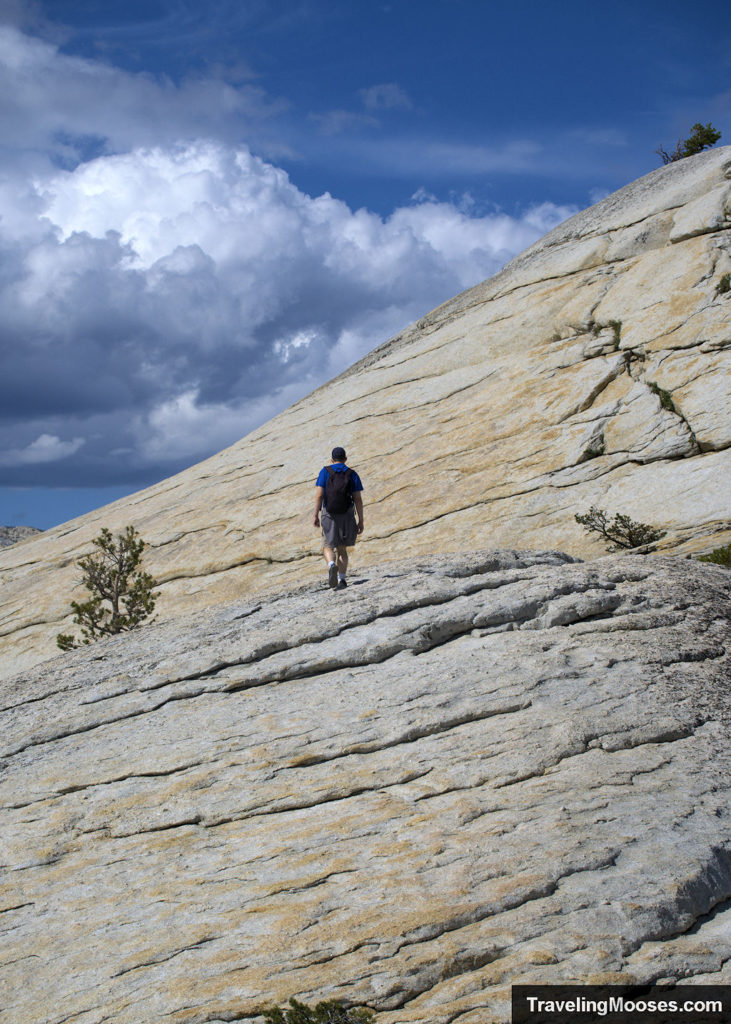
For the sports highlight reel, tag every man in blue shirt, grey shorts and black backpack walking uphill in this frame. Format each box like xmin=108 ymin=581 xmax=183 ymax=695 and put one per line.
xmin=312 ymin=447 xmax=363 ymax=590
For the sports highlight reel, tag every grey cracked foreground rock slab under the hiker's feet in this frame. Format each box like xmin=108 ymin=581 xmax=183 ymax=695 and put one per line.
xmin=0 ymin=552 xmax=731 ymax=1024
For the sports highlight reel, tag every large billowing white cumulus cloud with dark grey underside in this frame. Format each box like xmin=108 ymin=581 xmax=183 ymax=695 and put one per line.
xmin=0 ymin=140 xmax=570 ymax=483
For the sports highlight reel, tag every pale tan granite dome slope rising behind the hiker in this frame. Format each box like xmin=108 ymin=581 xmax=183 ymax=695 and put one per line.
xmin=0 ymin=147 xmax=731 ymax=672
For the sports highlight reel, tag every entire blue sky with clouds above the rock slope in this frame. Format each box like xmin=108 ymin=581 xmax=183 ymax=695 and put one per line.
xmin=0 ymin=0 xmax=731 ymax=529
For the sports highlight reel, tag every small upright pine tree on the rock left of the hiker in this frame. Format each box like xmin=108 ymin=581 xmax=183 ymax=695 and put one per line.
xmin=56 ymin=526 xmax=157 ymax=650
